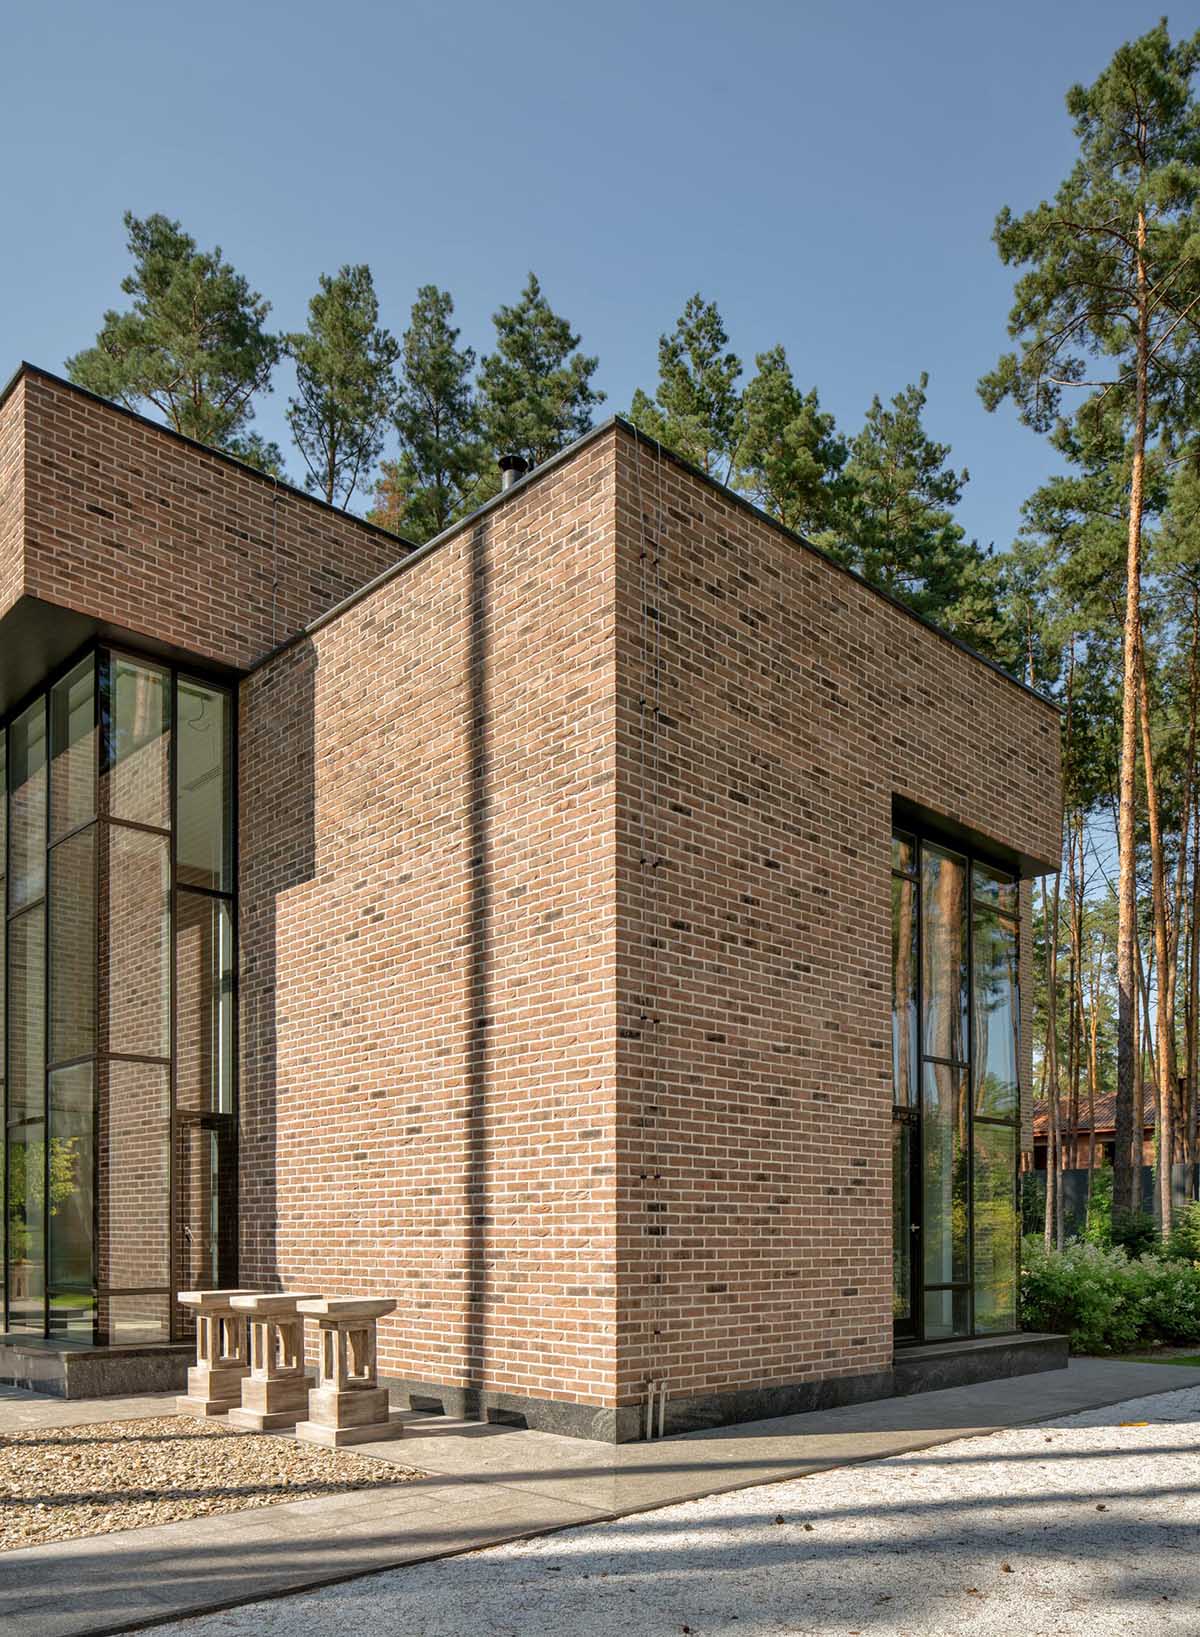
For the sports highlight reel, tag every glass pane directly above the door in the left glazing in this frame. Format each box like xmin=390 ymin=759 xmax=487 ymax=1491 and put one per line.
xmin=175 ymin=892 xmax=234 ymax=1113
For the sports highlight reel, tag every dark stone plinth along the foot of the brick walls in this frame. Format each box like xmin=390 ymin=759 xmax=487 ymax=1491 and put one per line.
xmin=381 ymin=1334 xmax=1067 ymax=1444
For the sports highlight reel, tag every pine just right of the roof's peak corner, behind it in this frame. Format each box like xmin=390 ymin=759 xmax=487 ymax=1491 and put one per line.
xmin=629 ymin=293 xmax=742 ymax=483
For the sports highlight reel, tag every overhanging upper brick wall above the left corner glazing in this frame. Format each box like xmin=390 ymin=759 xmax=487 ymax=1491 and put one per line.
xmin=9 ymin=372 xmax=406 ymax=666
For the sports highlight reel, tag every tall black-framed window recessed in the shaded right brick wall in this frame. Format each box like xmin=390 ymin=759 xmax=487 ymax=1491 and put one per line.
xmin=892 ymin=830 xmax=1020 ymax=1341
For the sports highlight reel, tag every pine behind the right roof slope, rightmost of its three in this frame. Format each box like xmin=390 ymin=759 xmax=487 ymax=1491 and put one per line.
xmin=840 ymin=375 xmax=1013 ymax=663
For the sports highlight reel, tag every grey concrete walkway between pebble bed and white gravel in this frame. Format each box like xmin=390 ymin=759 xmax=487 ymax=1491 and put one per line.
xmin=0 ymin=1359 xmax=1200 ymax=1637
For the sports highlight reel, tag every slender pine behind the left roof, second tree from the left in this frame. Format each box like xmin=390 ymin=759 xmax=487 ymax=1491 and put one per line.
xmin=288 ymin=265 xmax=399 ymax=507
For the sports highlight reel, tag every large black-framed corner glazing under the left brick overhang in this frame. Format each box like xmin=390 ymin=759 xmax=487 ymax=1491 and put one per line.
xmin=0 ymin=648 xmax=236 ymax=1342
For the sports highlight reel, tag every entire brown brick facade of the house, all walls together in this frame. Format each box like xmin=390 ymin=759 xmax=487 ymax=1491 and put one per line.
xmin=0 ymin=375 xmax=1059 ymax=1437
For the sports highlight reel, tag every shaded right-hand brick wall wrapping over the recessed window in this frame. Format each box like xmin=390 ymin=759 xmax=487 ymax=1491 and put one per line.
xmin=617 ymin=432 xmax=1059 ymax=1403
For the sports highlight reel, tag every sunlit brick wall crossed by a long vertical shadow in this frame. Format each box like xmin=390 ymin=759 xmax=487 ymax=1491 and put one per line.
xmin=241 ymin=434 xmax=616 ymax=1405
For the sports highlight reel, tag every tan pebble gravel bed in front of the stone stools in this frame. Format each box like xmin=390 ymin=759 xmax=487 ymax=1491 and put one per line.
xmin=0 ymin=1416 xmax=421 ymax=1552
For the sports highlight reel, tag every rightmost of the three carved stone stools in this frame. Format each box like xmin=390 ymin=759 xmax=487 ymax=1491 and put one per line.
xmin=296 ymin=1297 xmax=404 ymax=1449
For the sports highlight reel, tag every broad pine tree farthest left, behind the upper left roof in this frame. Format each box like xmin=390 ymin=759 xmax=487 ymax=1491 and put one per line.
xmin=67 ymin=211 xmax=280 ymax=453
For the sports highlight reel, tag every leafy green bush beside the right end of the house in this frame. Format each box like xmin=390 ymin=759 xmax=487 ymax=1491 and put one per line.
xmin=1022 ymin=1231 xmax=1200 ymax=1352
